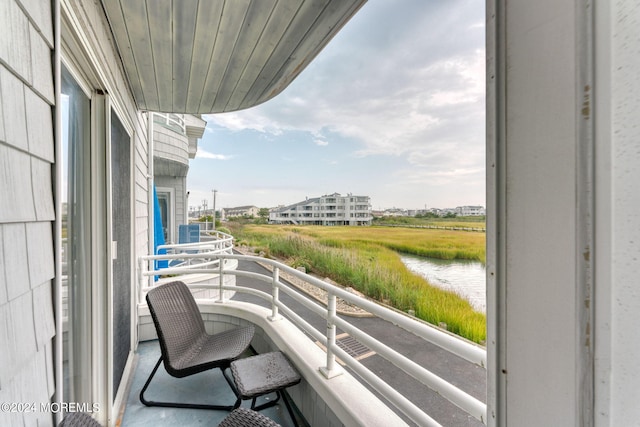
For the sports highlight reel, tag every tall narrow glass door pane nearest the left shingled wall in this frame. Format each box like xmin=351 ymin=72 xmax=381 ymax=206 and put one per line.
xmin=60 ymin=64 xmax=92 ymax=402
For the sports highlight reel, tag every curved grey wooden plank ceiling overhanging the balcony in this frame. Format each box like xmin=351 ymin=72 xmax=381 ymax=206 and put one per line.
xmin=102 ymin=0 xmax=366 ymax=114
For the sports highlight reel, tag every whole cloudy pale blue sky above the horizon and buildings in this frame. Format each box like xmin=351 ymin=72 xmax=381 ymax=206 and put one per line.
xmin=187 ymin=0 xmax=485 ymax=209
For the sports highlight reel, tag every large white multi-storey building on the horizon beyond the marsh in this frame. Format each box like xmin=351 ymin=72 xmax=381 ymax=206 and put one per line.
xmin=269 ymin=193 xmax=373 ymax=225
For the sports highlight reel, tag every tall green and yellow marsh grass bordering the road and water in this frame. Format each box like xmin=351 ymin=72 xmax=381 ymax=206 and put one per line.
xmin=232 ymin=225 xmax=486 ymax=343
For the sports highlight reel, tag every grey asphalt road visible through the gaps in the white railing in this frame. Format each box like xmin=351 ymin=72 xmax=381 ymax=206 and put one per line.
xmin=233 ymin=260 xmax=486 ymax=426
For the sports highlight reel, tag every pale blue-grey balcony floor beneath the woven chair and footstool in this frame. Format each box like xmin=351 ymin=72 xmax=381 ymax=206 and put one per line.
xmin=119 ymin=341 xmax=307 ymax=427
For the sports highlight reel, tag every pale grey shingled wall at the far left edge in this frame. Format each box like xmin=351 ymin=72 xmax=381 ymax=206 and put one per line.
xmin=0 ymin=0 xmax=55 ymax=426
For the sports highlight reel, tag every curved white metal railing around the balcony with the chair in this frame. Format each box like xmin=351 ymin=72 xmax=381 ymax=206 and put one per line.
xmin=139 ymin=244 xmax=487 ymax=426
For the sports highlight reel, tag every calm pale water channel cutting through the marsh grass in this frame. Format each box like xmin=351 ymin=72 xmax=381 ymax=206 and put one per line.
xmin=400 ymin=255 xmax=487 ymax=313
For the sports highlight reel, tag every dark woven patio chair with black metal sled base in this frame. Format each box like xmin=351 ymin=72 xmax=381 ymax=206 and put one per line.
xmin=140 ymin=282 xmax=254 ymax=411
